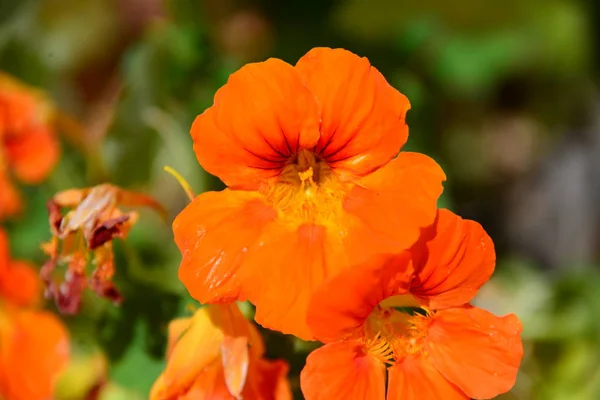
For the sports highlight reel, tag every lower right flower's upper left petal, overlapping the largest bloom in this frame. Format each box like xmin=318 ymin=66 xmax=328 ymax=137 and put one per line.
xmin=307 ymin=253 xmax=412 ymax=343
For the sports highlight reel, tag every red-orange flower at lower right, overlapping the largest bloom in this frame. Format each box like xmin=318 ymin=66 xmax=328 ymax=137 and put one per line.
xmin=301 ymin=210 xmax=523 ymax=400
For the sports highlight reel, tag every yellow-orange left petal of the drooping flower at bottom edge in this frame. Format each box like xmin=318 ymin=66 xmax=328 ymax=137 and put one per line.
xmin=151 ymin=307 xmax=223 ymax=399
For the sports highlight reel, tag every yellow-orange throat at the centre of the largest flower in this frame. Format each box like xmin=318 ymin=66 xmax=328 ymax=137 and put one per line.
xmin=263 ymin=149 xmax=349 ymax=228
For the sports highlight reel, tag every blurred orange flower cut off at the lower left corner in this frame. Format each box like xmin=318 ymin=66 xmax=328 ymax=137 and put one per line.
xmin=0 ymin=230 xmax=69 ymax=400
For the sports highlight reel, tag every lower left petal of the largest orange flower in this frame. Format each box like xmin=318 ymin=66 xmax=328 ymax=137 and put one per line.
xmin=173 ymin=190 xmax=275 ymax=303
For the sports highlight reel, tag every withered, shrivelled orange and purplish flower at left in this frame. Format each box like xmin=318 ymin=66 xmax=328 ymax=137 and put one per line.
xmin=40 ymin=184 xmax=165 ymax=314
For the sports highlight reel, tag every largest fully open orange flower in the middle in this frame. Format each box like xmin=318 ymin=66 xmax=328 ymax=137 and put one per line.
xmin=173 ymin=48 xmax=445 ymax=338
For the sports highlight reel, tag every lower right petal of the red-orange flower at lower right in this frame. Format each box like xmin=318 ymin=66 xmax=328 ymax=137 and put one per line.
xmin=428 ymin=306 xmax=523 ymax=399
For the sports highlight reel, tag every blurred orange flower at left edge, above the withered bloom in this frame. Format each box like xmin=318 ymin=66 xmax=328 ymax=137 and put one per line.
xmin=0 ymin=72 xmax=60 ymax=219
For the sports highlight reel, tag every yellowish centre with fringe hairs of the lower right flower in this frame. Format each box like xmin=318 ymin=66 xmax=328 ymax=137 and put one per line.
xmin=364 ymin=296 xmax=430 ymax=365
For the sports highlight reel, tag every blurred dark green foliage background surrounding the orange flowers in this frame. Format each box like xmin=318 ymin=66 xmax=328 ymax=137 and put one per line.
xmin=0 ymin=0 xmax=600 ymax=400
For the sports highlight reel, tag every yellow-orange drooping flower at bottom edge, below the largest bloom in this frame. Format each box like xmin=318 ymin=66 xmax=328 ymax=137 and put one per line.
xmin=150 ymin=304 xmax=292 ymax=400
